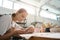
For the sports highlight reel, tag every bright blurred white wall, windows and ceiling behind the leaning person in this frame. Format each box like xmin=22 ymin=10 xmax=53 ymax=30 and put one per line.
xmin=0 ymin=0 xmax=60 ymax=26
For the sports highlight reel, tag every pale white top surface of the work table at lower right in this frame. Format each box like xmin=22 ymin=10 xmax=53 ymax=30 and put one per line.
xmin=20 ymin=33 xmax=60 ymax=39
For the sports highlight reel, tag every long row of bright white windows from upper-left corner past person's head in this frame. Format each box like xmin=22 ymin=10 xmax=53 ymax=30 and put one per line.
xmin=0 ymin=0 xmax=36 ymax=15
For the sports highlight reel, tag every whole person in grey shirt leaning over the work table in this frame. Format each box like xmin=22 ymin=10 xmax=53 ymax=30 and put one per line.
xmin=0 ymin=9 xmax=34 ymax=40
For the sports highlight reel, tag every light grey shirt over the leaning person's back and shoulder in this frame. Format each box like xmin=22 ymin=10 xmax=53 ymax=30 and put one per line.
xmin=0 ymin=15 xmax=11 ymax=35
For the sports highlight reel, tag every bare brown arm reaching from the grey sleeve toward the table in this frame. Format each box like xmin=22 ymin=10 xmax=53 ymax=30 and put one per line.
xmin=0 ymin=28 xmax=25 ymax=40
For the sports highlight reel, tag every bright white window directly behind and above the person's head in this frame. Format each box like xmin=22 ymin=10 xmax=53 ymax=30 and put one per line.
xmin=14 ymin=3 xmax=35 ymax=15
